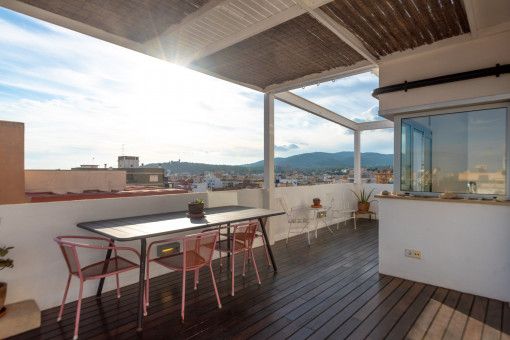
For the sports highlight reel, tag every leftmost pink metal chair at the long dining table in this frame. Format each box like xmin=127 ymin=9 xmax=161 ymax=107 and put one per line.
xmin=54 ymin=236 xmax=140 ymax=340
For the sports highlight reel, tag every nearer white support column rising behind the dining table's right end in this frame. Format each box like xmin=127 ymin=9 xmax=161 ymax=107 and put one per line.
xmin=263 ymin=93 xmax=274 ymax=244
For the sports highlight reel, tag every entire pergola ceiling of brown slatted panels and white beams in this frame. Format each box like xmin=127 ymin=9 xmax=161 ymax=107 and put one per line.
xmin=6 ymin=0 xmax=469 ymax=91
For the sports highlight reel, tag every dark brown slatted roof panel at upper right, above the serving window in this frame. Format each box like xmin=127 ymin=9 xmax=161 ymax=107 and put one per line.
xmin=321 ymin=0 xmax=469 ymax=58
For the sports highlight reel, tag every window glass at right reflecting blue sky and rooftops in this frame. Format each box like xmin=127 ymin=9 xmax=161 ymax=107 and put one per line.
xmin=402 ymin=108 xmax=507 ymax=193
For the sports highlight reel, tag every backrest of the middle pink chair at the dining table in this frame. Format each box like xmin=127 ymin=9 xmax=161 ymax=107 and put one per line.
xmin=182 ymin=231 xmax=218 ymax=267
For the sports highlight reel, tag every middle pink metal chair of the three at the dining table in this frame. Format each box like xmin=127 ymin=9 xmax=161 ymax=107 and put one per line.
xmin=144 ymin=231 xmax=221 ymax=322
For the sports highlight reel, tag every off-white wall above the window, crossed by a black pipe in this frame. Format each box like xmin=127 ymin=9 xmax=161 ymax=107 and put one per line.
xmin=379 ymin=31 xmax=510 ymax=112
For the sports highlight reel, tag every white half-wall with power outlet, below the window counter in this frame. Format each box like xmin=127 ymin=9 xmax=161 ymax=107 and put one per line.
xmin=379 ymin=198 xmax=510 ymax=301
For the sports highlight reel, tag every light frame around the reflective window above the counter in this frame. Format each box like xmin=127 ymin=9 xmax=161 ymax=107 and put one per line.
xmin=393 ymin=102 xmax=510 ymax=199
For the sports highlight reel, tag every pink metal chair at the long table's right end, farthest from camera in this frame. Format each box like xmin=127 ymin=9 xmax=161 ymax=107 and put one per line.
xmin=216 ymin=222 xmax=261 ymax=296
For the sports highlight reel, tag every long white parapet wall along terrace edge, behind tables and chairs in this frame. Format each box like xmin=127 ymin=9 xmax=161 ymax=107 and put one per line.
xmin=0 ymin=184 xmax=389 ymax=310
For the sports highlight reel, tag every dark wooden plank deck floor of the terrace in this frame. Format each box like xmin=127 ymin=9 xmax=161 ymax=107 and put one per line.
xmin=8 ymin=220 xmax=510 ymax=340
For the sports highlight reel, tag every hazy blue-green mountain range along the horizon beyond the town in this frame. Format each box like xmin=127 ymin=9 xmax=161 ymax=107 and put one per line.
xmin=144 ymin=151 xmax=393 ymax=175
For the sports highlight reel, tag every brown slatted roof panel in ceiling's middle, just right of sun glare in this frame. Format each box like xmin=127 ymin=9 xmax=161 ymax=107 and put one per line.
xmin=192 ymin=14 xmax=363 ymax=88
